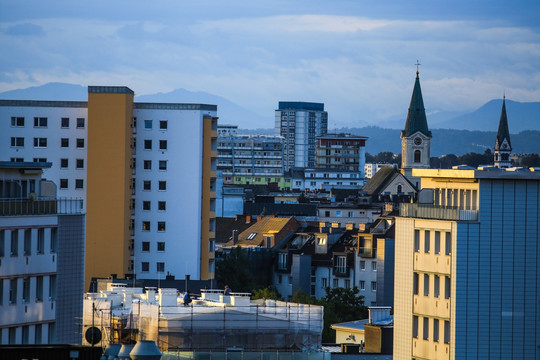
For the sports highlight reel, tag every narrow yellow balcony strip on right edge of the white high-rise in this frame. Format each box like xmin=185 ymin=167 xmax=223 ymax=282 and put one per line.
xmin=200 ymin=116 xmax=217 ymax=280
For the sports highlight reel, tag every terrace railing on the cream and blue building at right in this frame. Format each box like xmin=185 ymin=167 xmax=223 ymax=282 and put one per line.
xmin=399 ymin=203 xmax=478 ymax=221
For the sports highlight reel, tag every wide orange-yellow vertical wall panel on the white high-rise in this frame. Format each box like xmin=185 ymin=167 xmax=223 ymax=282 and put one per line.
xmin=85 ymin=88 xmax=133 ymax=290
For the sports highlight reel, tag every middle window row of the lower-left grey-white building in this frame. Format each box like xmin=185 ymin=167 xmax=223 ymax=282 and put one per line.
xmin=0 ymin=275 xmax=56 ymax=306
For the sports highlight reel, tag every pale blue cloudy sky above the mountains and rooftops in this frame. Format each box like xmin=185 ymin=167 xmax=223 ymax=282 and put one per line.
xmin=0 ymin=0 xmax=540 ymax=128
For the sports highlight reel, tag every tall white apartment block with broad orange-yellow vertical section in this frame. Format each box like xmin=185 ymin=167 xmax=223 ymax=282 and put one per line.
xmin=0 ymin=86 xmax=217 ymax=289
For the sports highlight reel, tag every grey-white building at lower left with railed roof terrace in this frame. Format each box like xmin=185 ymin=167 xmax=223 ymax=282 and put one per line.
xmin=0 ymin=161 xmax=85 ymax=344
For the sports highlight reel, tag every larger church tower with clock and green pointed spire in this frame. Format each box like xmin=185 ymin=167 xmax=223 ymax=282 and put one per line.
xmin=401 ymin=64 xmax=431 ymax=179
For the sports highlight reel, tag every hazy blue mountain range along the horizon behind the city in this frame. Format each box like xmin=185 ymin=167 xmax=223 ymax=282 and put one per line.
xmin=0 ymin=83 xmax=540 ymax=156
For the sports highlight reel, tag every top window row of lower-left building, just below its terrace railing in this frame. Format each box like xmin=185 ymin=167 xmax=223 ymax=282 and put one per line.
xmin=0 ymin=228 xmax=58 ymax=257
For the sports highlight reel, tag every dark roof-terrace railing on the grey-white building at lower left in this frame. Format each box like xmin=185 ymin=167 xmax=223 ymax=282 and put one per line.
xmin=0 ymin=198 xmax=83 ymax=216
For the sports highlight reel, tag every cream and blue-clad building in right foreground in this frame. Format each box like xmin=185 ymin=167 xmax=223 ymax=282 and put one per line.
xmin=394 ymin=168 xmax=540 ymax=359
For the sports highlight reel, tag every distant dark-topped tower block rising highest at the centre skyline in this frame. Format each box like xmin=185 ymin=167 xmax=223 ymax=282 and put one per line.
xmin=275 ymin=101 xmax=328 ymax=171
